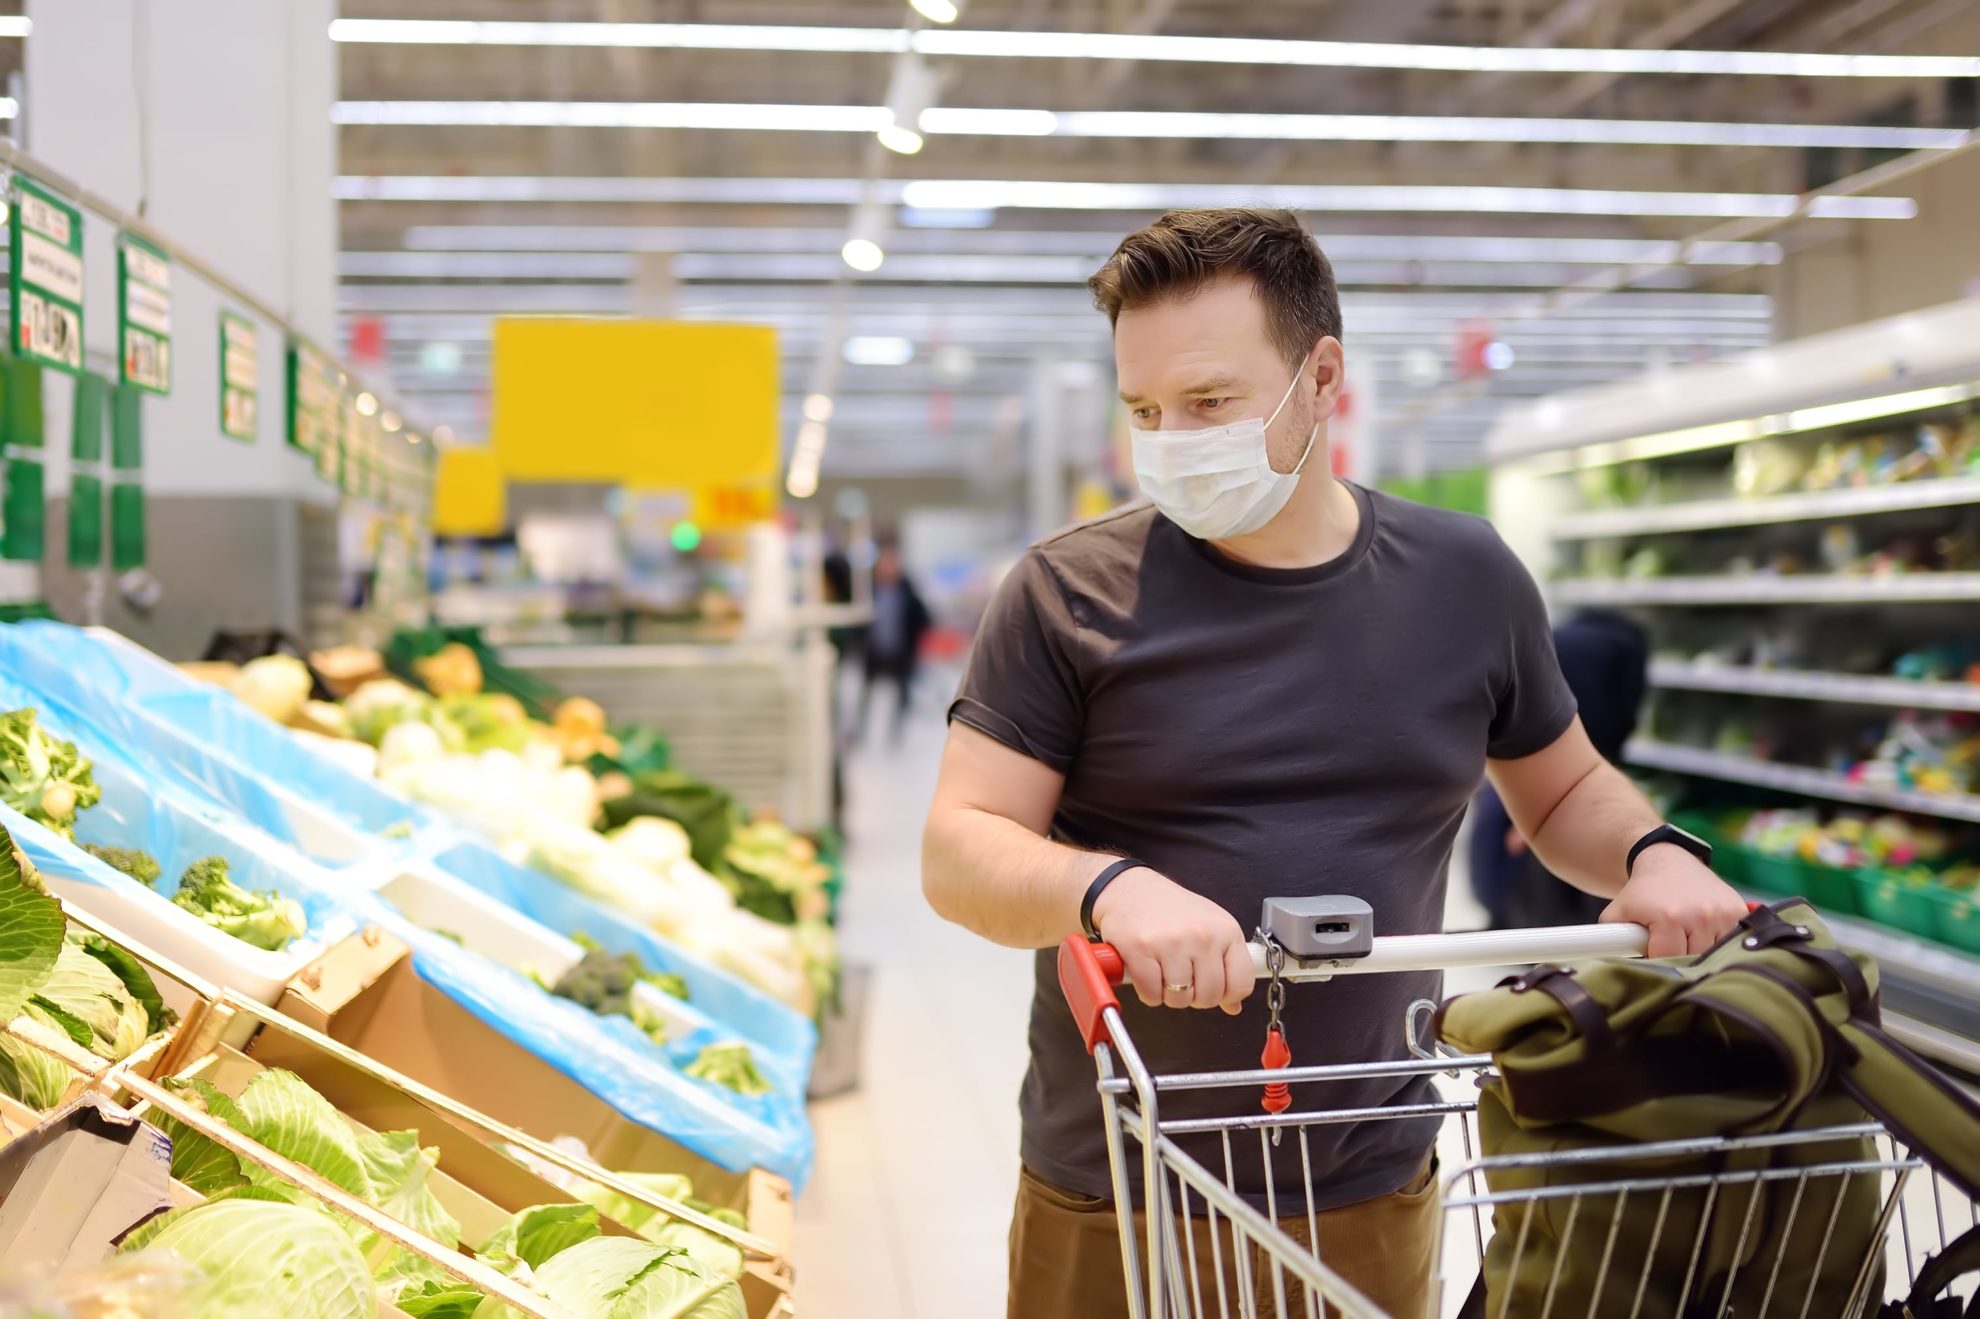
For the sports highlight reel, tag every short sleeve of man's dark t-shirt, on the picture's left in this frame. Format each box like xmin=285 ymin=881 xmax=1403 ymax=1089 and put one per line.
xmin=948 ymin=551 xmax=1085 ymax=774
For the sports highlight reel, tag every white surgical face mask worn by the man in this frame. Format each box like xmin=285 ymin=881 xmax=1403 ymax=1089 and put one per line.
xmin=1131 ymin=366 xmax=1321 ymax=541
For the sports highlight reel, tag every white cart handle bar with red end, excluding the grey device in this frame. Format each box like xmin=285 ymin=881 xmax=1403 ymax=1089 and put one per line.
xmin=1059 ymin=921 xmax=1649 ymax=1054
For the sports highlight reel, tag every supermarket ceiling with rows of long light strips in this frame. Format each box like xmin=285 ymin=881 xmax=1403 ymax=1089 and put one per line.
xmin=339 ymin=0 xmax=1976 ymax=491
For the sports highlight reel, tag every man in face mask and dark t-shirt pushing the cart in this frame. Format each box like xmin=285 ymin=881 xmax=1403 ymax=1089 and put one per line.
xmin=923 ymin=210 xmax=1744 ymax=1319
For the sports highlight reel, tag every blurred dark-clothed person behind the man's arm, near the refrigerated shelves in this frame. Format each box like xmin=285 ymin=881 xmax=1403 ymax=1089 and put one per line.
xmin=1469 ymin=610 xmax=1649 ymax=929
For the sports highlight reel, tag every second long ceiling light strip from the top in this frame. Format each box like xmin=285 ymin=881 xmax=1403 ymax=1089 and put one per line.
xmin=331 ymin=99 xmax=1932 ymax=154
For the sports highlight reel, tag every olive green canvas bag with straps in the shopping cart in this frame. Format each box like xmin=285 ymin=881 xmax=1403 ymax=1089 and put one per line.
xmin=1436 ymin=899 xmax=1980 ymax=1319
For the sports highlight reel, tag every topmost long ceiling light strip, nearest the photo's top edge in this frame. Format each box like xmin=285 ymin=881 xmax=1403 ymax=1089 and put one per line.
xmin=324 ymin=19 xmax=1980 ymax=79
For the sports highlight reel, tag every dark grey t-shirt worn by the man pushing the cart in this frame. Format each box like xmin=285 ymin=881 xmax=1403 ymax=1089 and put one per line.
xmin=950 ymin=487 xmax=1574 ymax=1212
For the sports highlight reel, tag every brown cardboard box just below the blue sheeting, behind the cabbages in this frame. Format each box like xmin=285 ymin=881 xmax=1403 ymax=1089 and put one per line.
xmin=271 ymin=929 xmax=794 ymax=1319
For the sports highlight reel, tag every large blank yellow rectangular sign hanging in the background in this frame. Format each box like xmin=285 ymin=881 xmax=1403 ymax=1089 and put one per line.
xmin=489 ymin=317 xmax=778 ymax=489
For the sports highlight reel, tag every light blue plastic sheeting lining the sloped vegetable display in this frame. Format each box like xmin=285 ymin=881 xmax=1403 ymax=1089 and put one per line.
xmin=0 ymin=624 xmax=818 ymax=1184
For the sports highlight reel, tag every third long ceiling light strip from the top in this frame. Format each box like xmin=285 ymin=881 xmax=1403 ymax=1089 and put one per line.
xmin=333 ymin=174 xmax=1919 ymax=220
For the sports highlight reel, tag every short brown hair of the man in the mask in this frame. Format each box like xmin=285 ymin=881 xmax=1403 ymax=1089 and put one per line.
xmin=1087 ymin=206 xmax=1340 ymax=364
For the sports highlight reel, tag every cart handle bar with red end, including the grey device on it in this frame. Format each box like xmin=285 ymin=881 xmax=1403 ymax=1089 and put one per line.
xmin=1059 ymin=897 xmax=1649 ymax=1050
